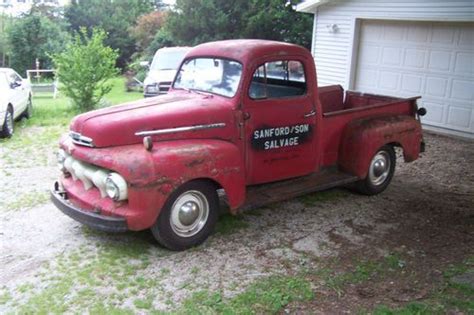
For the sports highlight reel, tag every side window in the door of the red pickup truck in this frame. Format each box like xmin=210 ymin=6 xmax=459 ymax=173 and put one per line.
xmin=249 ymin=60 xmax=306 ymax=99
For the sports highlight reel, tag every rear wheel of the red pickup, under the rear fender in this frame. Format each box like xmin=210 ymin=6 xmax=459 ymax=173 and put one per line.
xmin=355 ymin=145 xmax=396 ymax=196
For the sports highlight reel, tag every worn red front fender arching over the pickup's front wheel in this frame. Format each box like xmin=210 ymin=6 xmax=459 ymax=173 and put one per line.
xmin=61 ymin=136 xmax=245 ymax=230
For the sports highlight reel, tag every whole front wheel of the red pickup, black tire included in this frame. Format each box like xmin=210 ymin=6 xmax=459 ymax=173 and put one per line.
xmin=151 ymin=180 xmax=219 ymax=251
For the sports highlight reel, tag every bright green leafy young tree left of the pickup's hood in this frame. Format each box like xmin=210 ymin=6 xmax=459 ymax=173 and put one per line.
xmin=53 ymin=28 xmax=118 ymax=111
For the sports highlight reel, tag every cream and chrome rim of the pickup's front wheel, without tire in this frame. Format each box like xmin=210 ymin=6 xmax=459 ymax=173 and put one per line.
xmin=170 ymin=190 xmax=209 ymax=237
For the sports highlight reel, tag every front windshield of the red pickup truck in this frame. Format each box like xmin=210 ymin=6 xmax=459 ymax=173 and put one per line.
xmin=173 ymin=58 xmax=242 ymax=97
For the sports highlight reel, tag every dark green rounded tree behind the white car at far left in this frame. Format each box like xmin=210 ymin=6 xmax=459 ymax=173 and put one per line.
xmin=7 ymin=13 xmax=69 ymax=74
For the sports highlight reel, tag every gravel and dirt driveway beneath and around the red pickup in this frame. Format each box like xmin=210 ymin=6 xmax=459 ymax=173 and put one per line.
xmin=0 ymin=134 xmax=474 ymax=314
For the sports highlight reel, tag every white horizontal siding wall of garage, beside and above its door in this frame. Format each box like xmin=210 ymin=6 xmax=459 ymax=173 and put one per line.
xmin=312 ymin=0 xmax=474 ymax=88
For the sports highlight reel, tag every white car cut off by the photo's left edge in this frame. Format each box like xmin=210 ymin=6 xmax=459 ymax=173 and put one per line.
xmin=0 ymin=68 xmax=33 ymax=138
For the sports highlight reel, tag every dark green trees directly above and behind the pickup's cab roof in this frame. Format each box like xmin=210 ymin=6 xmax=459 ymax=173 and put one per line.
xmin=165 ymin=0 xmax=312 ymax=48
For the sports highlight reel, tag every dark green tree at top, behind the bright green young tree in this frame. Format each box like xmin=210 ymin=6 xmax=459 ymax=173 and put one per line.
xmin=64 ymin=0 xmax=155 ymax=68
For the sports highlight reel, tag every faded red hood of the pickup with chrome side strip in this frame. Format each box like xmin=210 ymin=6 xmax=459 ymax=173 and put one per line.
xmin=70 ymin=91 xmax=233 ymax=147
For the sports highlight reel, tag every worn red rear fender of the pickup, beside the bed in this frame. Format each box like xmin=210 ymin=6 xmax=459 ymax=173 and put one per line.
xmin=339 ymin=115 xmax=422 ymax=178
